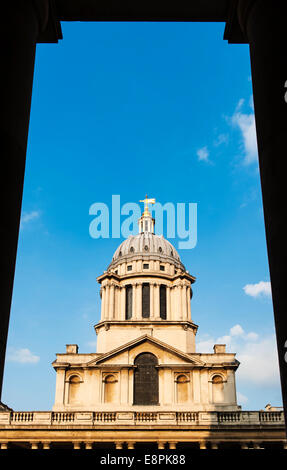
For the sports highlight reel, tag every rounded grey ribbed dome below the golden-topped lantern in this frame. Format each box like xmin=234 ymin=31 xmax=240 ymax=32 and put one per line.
xmin=108 ymin=232 xmax=185 ymax=271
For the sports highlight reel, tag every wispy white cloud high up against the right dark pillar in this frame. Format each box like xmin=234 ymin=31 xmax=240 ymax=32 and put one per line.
xmin=231 ymin=99 xmax=258 ymax=165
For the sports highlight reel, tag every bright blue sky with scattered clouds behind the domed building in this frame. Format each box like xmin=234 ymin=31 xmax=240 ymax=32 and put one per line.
xmin=3 ymin=23 xmax=281 ymax=410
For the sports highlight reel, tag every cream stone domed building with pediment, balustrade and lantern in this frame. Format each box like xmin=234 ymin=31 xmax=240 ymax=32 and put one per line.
xmin=0 ymin=198 xmax=285 ymax=448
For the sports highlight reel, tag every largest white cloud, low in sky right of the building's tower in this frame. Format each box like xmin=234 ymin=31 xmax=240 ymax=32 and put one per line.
xmin=196 ymin=324 xmax=280 ymax=388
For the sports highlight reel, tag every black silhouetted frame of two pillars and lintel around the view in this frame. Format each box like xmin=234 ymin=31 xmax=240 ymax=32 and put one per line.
xmin=0 ymin=0 xmax=287 ymax=436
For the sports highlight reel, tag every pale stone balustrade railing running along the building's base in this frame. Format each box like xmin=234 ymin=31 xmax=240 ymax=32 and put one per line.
xmin=0 ymin=411 xmax=284 ymax=427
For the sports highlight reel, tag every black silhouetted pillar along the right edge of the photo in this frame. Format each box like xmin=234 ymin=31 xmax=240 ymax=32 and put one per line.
xmin=234 ymin=0 xmax=287 ymax=423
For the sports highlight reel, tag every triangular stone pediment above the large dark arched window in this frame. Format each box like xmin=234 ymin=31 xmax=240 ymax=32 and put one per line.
xmin=86 ymin=335 xmax=205 ymax=367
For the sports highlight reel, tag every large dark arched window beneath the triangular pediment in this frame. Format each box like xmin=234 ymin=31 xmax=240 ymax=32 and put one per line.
xmin=134 ymin=353 xmax=158 ymax=405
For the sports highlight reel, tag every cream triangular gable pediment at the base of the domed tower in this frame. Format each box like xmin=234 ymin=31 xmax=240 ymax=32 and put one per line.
xmin=86 ymin=335 xmax=205 ymax=367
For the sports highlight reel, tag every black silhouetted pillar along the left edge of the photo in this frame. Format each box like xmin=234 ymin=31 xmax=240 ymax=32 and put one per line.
xmin=0 ymin=0 xmax=61 ymax=404
